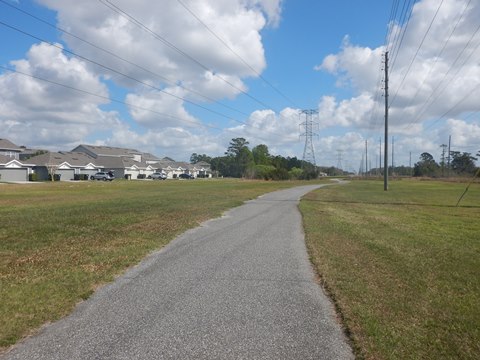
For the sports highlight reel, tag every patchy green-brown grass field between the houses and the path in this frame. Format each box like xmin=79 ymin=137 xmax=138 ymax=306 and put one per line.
xmin=0 ymin=179 xmax=314 ymax=349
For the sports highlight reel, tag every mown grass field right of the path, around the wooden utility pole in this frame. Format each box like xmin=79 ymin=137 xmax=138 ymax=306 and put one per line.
xmin=301 ymin=180 xmax=480 ymax=359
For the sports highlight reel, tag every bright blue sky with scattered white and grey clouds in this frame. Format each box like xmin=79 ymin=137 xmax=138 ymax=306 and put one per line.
xmin=0 ymin=0 xmax=480 ymax=171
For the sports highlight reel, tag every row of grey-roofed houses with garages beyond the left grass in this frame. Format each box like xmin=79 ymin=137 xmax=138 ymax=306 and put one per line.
xmin=0 ymin=139 xmax=212 ymax=181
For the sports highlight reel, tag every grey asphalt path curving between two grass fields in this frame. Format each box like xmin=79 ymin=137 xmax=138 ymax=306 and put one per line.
xmin=1 ymin=185 xmax=354 ymax=360
